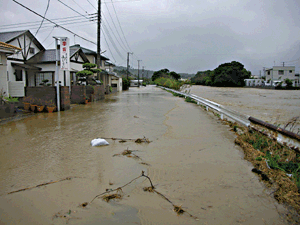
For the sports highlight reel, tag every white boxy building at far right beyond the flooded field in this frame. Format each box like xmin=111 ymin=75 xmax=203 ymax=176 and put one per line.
xmin=264 ymin=66 xmax=298 ymax=86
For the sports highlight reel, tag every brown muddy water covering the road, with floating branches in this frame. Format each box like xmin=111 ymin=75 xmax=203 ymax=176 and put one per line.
xmin=0 ymin=86 xmax=287 ymax=225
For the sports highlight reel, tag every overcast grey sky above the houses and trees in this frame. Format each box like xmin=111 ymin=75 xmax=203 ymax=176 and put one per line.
xmin=0 ymin=0 xmax=300 ymax=75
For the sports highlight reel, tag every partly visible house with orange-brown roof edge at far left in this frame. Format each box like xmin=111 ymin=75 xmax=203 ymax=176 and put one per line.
xmin=0 ymin=42 xmax=22 ymax=96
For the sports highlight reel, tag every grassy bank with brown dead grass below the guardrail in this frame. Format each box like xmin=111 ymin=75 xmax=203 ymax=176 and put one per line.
xmin=232 ymin=122 xmax=300 ymax=222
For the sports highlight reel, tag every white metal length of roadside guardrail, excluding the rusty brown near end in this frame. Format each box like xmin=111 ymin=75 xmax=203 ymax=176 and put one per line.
xmin=161 ymin=87 xmax=250 ymax=127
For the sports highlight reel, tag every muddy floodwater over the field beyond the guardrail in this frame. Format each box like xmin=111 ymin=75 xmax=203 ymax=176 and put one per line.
xmin=191 ymin=85 xmax=300 ymax=133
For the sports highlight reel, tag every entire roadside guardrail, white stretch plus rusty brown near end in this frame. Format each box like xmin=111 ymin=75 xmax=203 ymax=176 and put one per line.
xmin=160 ymin=87 xmax=300 ymax=149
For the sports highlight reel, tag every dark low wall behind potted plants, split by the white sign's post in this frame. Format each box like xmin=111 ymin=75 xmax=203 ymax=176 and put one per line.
xmin=25 ymin=86 xmax=70 ymax=110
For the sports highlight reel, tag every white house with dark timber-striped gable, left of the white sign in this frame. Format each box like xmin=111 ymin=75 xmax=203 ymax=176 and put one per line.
xmin=0 ymin=30 xmax=45 ymax=97
